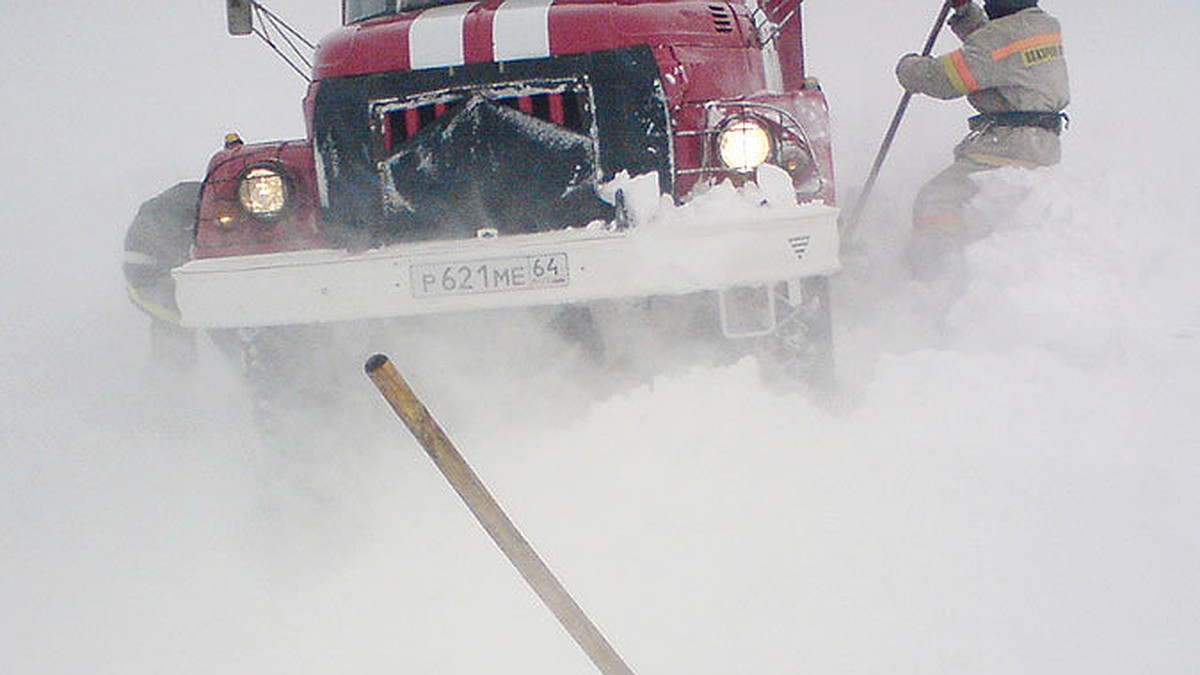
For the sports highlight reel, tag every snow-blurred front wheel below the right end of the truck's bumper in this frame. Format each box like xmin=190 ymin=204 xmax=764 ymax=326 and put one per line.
xmin=760 ymin=276 xmax=835 ymax=395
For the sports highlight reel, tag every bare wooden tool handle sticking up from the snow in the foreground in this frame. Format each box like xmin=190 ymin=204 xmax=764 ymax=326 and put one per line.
xmin=366 ymin=354 xmax=634 ymax=675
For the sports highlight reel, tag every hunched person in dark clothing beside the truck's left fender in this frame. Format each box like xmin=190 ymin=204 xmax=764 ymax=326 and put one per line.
xmin=122 ymin=181 xmax=200 ymax=368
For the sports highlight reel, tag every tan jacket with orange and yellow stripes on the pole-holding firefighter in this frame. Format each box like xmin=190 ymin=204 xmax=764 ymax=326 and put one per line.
xmin=896 ymin=2 xmax=1069 ymax=167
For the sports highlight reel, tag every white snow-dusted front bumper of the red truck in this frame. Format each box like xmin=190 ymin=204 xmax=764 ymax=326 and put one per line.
xmin=173 ymin=204 xmax=839 ymax=328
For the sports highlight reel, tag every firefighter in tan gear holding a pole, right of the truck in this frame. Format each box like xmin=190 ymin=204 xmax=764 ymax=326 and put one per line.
xmin=896 ymin=0 xmax=1069 ymax=279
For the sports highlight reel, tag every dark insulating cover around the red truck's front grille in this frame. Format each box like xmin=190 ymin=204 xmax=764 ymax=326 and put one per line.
xmin=312 ymin=47 xmax=673 ymax=247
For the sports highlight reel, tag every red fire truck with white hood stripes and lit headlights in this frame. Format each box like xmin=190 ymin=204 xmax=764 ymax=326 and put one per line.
xmin=125 ymin=0 xmax=839 ymax=403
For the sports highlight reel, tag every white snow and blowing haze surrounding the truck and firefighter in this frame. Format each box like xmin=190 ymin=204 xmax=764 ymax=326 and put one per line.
xmin=0 ymin=0 xmax=1200 ymax=675
